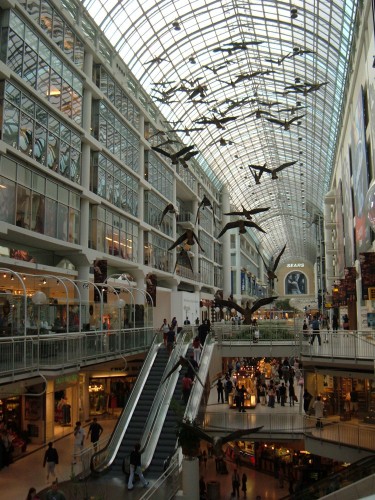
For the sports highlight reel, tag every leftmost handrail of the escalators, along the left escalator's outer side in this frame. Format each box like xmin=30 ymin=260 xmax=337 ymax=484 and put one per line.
xmin=90 ymin=333 xmax=160 ymax=472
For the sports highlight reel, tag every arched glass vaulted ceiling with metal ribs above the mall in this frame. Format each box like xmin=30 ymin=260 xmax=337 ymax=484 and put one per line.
xmin=83 ymin=0 xmax=358 ymax=262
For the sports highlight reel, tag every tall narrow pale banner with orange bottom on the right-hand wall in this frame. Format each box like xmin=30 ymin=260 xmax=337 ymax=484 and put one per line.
xmin=351 ymin=88 xmax=371 ymax=254
